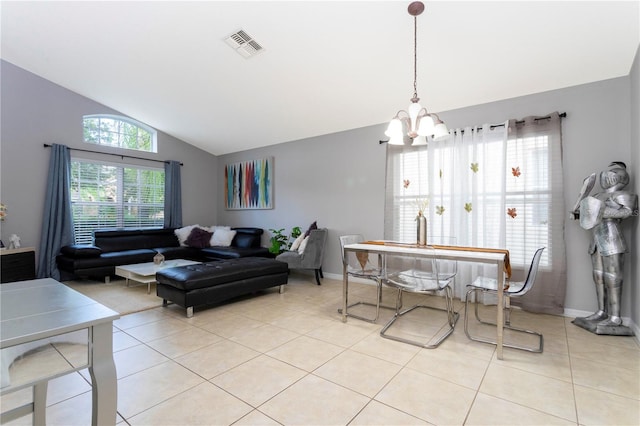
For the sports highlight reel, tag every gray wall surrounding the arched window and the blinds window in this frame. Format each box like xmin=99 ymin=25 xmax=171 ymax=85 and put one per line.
xmin=0 ymin=61 xmax=219 ymax=248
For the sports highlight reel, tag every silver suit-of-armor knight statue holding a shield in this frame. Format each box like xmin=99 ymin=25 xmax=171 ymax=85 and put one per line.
xmin=571 ymin=161 xmax=638 ymax=336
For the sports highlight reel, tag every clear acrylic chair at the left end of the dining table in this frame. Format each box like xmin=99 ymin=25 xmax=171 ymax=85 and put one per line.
xmin=338 ymin=234 xmax=390 ymax=323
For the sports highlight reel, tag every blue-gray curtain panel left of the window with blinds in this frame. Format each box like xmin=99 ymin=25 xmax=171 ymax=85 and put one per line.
xmin=38 ymin=144 xmax=74 ymax=280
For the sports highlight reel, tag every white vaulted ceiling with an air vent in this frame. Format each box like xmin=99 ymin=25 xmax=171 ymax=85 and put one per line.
xmin=1 ymin=1 xmax=640 ymax=155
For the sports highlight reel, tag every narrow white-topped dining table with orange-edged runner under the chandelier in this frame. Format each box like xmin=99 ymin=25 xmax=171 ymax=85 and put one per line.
xmin=342 ymin=240 xmax=511 ymax=360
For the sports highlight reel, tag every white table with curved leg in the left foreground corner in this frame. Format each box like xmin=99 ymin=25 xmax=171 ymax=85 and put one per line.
xmin=0 ymin=278 xmax=120 ymax=426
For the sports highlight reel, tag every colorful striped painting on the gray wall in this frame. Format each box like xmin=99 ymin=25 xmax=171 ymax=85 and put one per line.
xmin=224 ymin=157 xmax=273 ymax=210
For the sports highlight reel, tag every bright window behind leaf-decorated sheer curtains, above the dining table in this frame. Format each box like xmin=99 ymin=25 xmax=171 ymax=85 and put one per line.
xmin=390 ymin=136 xmax=551 ymax=266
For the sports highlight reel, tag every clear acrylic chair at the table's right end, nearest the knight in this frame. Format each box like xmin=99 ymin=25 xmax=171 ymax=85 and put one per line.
xmin=464 ymin=247 xmax=545 ymax=353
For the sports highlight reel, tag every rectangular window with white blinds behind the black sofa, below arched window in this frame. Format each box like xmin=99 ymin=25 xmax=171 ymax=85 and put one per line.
xmin=71 ymin=159 xmax=164 ymax=244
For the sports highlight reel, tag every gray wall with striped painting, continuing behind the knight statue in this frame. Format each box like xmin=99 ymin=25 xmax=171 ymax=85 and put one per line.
xmin=218 ymin=71 xmax=638 ymax=324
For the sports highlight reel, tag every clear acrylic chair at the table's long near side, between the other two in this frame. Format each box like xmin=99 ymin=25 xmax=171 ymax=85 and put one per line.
xmin=380 ymin=246 xmax=459 ymax=349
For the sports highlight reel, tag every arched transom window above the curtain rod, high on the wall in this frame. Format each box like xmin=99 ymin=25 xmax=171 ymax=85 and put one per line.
xmin=83 ymin=114 xmax=158 ymax=152
